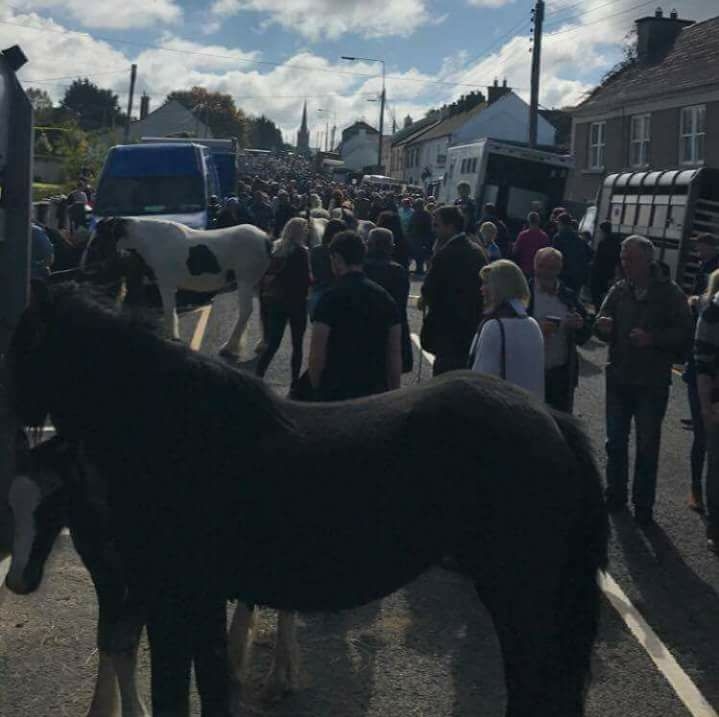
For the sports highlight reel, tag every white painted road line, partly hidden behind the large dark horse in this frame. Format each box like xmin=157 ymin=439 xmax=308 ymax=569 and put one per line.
xmin=412 ymin=334 xmax=719 ymax=717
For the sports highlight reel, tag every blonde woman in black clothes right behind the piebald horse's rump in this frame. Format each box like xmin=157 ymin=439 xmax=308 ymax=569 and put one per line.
xmin=257 ymin=217 xmax=310 ymax=383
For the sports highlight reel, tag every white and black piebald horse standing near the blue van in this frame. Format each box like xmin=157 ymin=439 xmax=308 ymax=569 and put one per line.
xmin=84 ymin=218 xmax=271 ymax=356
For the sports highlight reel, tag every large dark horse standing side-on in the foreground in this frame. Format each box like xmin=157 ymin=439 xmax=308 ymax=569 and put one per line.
xmin=9 ymin=285 xmax=608 ymax=717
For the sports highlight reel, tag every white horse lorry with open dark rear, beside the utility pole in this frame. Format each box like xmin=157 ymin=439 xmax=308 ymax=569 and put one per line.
xmin=440 ymin=139 xmax=574 ymax=228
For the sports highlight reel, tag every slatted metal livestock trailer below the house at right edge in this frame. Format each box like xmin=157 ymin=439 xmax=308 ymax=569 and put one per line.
xmin=594 ymin=167 xmax=719 ymax=291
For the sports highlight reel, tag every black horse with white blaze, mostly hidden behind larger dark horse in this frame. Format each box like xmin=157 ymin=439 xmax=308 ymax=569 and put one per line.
xmin=6 ymin=436 xmax=149 ymax=717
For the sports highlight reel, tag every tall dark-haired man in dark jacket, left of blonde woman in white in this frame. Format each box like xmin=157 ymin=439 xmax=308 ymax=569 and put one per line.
xmin=422 ymin=207 xmax=487 ymax=376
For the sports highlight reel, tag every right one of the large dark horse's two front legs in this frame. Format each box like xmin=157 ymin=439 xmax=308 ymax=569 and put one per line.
xmin=192 ymin=598 xmax=231 ymax=717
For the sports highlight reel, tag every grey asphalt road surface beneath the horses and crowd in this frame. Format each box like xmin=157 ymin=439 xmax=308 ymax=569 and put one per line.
xmin=0 ymin=284 xmax=719 ymax=717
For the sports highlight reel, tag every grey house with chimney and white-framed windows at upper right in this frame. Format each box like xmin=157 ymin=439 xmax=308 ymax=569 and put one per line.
xmin=567 ymin=9 xmax=719 ymax=201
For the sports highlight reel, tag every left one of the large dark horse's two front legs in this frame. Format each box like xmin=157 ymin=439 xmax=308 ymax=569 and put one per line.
xmin=147 ymin=593 xmax=194 ymax=717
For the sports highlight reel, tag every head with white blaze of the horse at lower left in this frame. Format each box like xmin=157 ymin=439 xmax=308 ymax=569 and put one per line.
xmin=5 ymin=438 xmax=71 ymax=595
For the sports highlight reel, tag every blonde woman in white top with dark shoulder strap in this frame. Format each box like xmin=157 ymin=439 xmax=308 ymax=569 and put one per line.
xmin=470 ymin=259 xmax=544 ymax=401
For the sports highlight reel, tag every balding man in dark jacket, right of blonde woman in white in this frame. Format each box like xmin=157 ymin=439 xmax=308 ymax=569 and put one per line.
xmin=528 ymin=247 xmax=592 ymax=413
